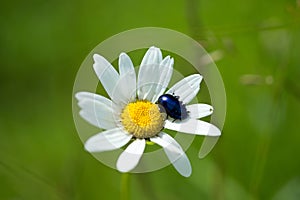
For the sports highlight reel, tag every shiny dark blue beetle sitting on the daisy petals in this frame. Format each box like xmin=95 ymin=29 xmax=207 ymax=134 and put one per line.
xmin=157 ymin=94 xmax=187 ymax=121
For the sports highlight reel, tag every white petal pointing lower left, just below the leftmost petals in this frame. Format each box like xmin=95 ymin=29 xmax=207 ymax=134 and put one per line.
xmin=84 ymin=128 xmax=132 ymax=152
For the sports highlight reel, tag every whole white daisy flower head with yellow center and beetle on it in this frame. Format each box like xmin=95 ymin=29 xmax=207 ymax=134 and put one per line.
xmin=76 ymin=47 xmax=221 ymax=177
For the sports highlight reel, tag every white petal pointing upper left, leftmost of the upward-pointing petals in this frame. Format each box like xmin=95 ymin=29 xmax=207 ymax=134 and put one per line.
xmin=93 ymin=54 xmax=119 ymax=96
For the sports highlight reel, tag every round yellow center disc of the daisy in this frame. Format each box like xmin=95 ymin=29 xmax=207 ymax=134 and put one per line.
xmin=121 ymin=101 xmax=165 ymax=138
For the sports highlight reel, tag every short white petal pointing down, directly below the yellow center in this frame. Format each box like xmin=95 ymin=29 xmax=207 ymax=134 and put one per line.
xmin=117 ymin=139 xmax=146 ymax=172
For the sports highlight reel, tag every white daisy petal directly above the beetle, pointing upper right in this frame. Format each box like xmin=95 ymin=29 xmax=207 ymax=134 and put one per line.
xmin=166 ymin=74 xmax=202 ymax=104
